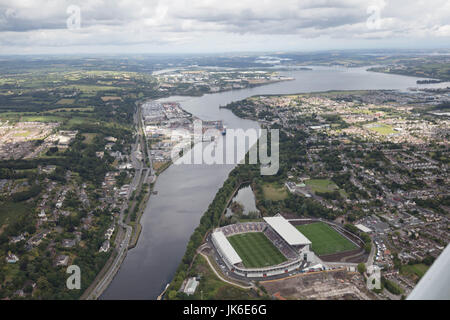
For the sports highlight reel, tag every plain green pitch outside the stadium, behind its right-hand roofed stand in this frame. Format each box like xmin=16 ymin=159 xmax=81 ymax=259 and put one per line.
xmin=296 ymin=222 xmax=358 ymax=256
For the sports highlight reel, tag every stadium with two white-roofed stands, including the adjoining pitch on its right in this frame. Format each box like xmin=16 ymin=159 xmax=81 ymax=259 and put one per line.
xmin=210 ymin=214 xmax=364 ymax=278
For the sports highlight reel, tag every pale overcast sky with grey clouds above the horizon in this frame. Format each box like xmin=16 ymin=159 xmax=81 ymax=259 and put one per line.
xmin=0 ymin=0 xmax=450 ymax=54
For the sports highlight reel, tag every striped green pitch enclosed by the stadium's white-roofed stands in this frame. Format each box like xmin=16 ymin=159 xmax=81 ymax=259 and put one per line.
xmin=228 ymin=232 xmax=286 ymax=268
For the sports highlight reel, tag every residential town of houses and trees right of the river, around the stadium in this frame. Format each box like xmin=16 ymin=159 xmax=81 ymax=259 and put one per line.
xmin=174 ymin=90 xmax=450 ymax=300
